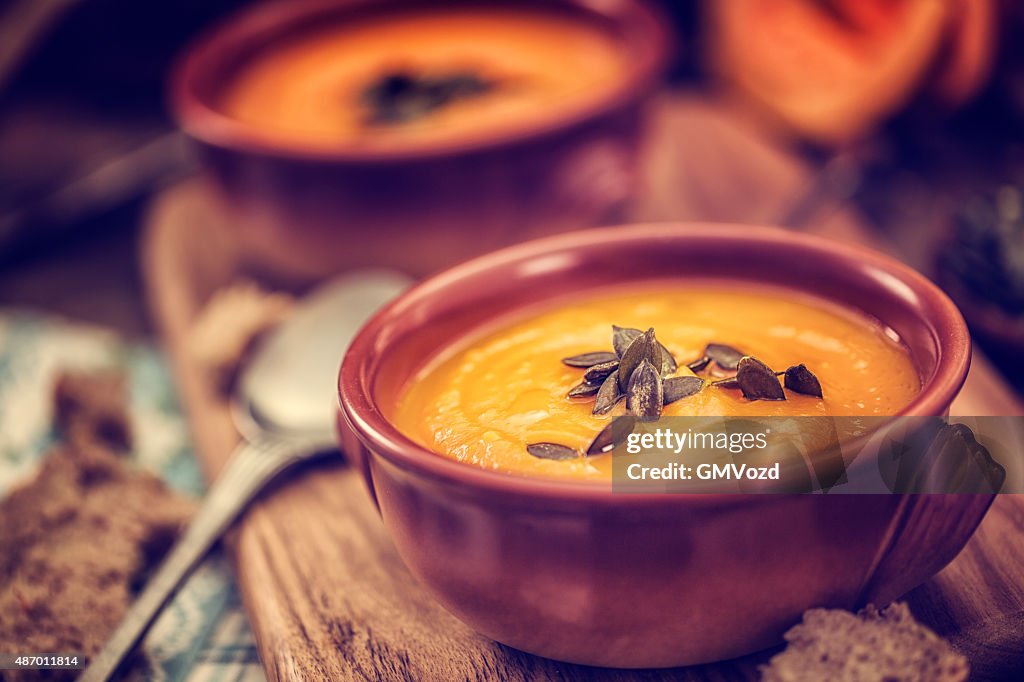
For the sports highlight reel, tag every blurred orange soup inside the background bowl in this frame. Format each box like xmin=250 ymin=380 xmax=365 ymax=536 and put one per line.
xmin=222 ymin=6 xmax=625 ymax=148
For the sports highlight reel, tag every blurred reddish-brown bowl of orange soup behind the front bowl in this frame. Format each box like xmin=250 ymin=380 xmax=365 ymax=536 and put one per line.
xmin=171 ymin=0 xmax=672 ymax=278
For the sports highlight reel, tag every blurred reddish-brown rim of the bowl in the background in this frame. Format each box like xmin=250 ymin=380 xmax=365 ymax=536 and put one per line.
xmin=167 ymin=0 xmax=675 ymax=164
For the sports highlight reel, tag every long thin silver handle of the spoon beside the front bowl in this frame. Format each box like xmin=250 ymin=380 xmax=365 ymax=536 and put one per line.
xmin=79 ymin=439 xmax=307 ymax=682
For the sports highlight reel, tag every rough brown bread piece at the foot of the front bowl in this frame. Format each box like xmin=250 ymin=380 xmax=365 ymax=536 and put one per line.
xmin=761 ymin=603 xmax=970 ymax=682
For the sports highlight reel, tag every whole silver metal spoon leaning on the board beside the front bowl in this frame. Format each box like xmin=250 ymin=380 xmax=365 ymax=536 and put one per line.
xmin=79 ymin=270 xmax=411 ymax=682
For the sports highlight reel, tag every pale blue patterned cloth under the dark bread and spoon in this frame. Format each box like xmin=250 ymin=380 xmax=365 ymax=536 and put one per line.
xmin=0 ymin=310 xmax=266 ymax=682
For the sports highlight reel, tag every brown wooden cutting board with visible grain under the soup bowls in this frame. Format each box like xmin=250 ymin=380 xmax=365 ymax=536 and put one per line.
xmin=142 ymin=100 xmax=1024 ymax=681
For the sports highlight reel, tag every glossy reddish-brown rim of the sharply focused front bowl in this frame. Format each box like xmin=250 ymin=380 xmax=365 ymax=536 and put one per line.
xmin=338 ymin=221 xmax=972 ymax=499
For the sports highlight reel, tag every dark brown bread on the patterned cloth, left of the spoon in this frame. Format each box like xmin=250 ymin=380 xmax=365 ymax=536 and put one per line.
xmin=0 ymin=373 xmax=196 ymax=682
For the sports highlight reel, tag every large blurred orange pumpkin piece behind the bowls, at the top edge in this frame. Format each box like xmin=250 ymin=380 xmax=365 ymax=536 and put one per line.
xmin=706 ymin=0 xmax=946 ymax=145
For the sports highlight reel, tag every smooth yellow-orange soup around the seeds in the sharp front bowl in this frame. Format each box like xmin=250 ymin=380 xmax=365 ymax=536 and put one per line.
xmin=389 ymin=284 xmax=921 ymax=479
